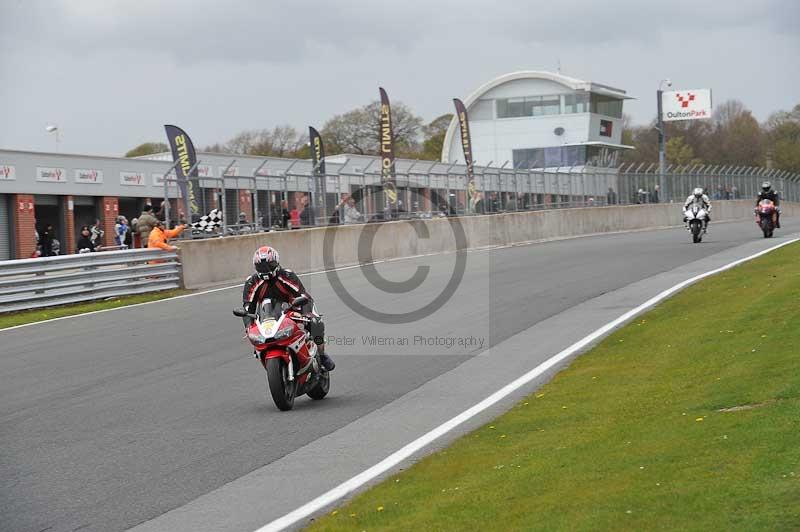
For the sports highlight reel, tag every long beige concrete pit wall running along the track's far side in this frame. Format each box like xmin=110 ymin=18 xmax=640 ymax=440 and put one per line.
xmin=180 ymin=200 xmax=800 ymax=288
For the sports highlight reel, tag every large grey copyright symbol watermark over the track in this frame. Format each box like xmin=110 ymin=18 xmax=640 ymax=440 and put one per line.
xmin=322 ymin=190 xmax=467 ymax=324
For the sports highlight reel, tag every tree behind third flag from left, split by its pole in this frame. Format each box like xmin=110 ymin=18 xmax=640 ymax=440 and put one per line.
xmin=320 ymin=101 xmax=422 ymax=157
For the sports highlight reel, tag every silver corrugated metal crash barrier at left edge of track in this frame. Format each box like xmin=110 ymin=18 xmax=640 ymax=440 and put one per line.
xmin=0 ymin=249 xmax=180 ymax=312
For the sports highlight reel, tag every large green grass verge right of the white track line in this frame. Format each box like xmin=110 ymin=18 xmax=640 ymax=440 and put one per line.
xmin=310 ymin=244 xmax=800 ymax=531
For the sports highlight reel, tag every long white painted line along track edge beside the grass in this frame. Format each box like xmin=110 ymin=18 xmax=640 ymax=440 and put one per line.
xmin=255 ymin=238 xmax=800 ymax=532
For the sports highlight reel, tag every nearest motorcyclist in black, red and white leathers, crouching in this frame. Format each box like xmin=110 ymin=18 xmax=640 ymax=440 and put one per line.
xmin=242 ymin=246 xmax=336 ymax=371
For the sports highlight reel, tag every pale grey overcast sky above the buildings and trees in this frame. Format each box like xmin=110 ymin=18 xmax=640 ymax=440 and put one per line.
xmin=0 ymin=0 xmax=800 ymax=156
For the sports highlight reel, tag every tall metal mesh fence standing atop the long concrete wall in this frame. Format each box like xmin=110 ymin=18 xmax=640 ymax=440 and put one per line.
xmin=177 ymin=161 xmax=800 ymax=237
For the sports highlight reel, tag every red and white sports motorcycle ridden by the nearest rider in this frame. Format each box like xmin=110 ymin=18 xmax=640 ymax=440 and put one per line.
xmin=233 ymin=296 xmax=331 ymax=411
